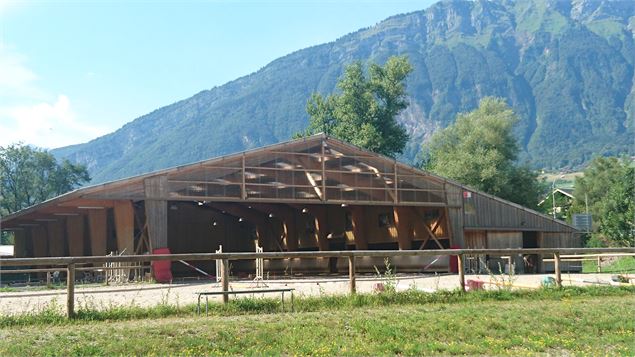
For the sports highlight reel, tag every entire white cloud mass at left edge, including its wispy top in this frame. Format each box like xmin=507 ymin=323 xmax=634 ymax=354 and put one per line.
xmin=0 ymin=44 xmax=108 ymax=148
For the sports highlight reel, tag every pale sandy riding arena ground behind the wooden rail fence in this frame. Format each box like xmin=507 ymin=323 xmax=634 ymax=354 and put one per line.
xmin=0 ymin=273 xmax=628 ymax=315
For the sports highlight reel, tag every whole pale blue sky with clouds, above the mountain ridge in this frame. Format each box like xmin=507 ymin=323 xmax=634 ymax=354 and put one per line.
xmin=0 ymin=0 xmax=434 ymax=148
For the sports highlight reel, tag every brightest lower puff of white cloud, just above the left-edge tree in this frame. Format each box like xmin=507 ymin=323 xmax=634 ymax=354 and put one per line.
xmin=0 ymin=95 xmax=108 ymax=148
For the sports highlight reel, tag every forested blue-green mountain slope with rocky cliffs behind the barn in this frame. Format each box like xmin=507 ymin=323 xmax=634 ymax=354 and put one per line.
xmin=53 ymin=0 xmax=635 ymax=182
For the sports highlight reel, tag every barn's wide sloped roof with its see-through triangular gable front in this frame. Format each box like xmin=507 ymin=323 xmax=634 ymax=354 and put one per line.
xmin=3 ymin=134 xmax=576 ymax=231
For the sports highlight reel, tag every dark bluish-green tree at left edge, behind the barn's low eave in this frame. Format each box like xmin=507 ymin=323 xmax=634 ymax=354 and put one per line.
xmin=0 ymin=144 xmax=90 ymax=215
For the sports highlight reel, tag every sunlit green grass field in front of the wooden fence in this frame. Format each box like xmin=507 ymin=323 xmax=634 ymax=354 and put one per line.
xmin=0 ymin=287 xmax=635 ymax=355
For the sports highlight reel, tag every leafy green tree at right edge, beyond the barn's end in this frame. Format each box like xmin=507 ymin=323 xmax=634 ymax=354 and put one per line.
xmin=572 ymin=157 xmax=635 ymax=246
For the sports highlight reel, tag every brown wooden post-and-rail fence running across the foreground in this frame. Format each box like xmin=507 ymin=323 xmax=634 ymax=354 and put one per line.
xmin=0 ymin=248 xmax=635 ymax=318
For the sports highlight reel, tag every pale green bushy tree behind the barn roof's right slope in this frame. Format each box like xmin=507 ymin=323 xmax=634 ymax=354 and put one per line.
xmin=422 ymin=97 xmax=542 ymax=208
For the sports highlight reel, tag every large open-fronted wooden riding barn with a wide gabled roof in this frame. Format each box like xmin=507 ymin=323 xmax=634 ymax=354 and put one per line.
xmin=2 ymin=135 xmax=580 ymax=273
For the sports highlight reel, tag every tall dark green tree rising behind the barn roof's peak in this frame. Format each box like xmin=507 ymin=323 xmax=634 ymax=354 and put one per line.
xmin=296 ymin=57 xmax=412 ymax=157
